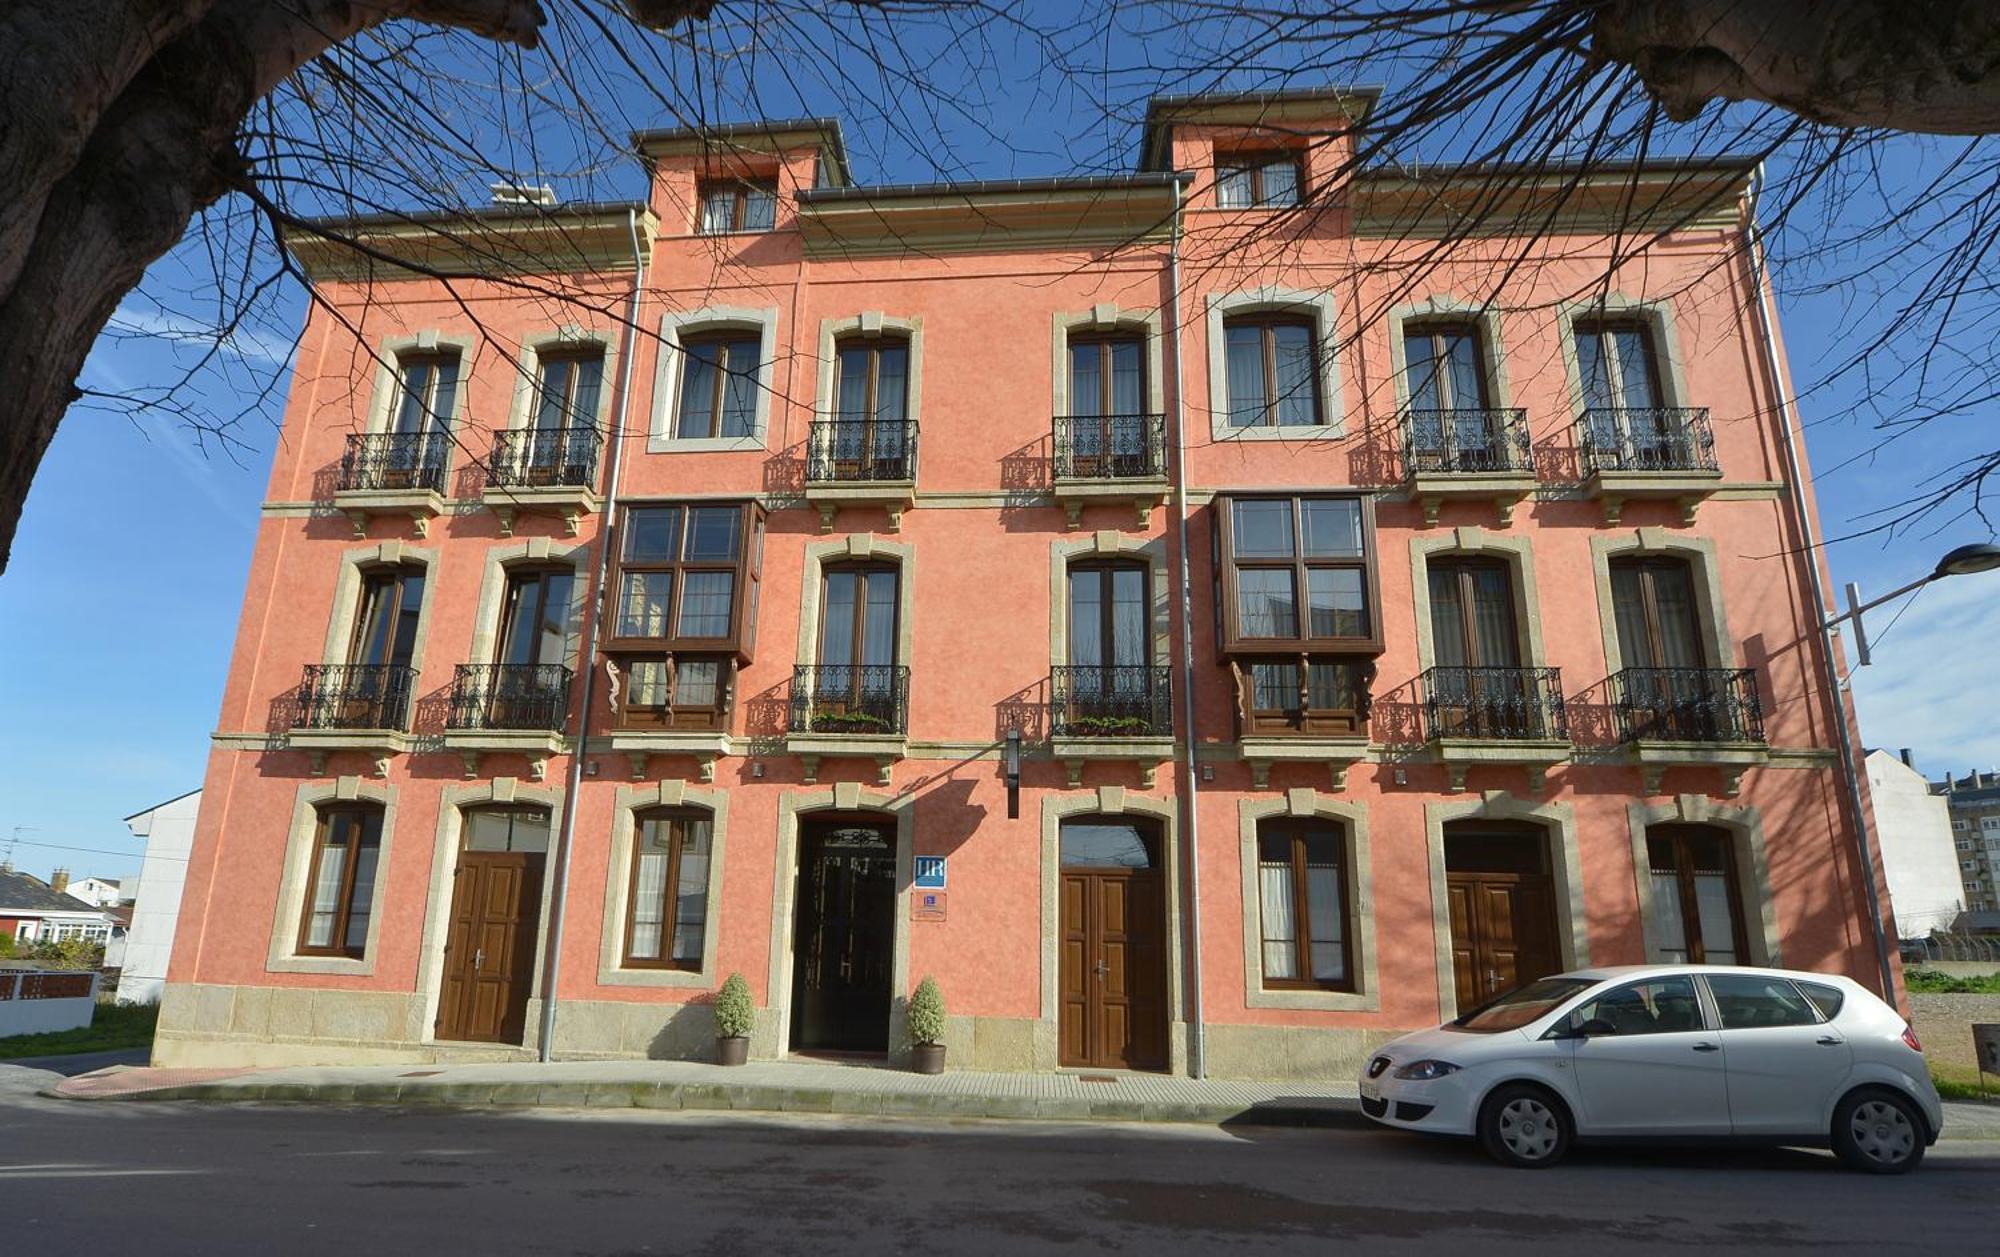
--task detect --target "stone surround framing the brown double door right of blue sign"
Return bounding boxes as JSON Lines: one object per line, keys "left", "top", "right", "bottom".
{"left": 1034, "top": 787, "right": 1188, "bottom": 1077}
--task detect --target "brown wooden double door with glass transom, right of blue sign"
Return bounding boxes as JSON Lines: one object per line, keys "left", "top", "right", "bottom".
{"left": 1056, "top": 821, "right": 1168, "bottom": 1069}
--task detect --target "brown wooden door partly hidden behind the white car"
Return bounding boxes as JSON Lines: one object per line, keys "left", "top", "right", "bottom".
{"left": 1444, "top": 827, "right": 1562, "bottom": 1013}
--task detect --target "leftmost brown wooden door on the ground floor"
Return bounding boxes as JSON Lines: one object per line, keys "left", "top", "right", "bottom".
{"left": 434, "top": 851, "right": 544, "bottom": 1043}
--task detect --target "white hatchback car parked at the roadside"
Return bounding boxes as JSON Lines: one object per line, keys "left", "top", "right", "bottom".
{"left": 1360, "top": 965, "right": 1944, "bottom": 1173}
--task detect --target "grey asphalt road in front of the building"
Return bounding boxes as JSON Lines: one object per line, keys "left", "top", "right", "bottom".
{"left": 0, "top": 1065, "right": 2000, "bottom": 1257}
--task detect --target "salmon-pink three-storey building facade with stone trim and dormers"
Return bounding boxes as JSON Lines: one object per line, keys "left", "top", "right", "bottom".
{"left": 156, "top": 92, "right": 1874, "bottom": 1077}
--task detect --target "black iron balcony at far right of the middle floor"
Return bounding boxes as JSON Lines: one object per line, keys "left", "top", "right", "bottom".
{"left": 1608, "top": 669, "right": 1770, "bottom": 797}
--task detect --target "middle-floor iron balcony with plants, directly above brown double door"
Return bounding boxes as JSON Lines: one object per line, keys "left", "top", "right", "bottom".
{"left": 1048, "top": 665, "right": 1174, "bottom": 789}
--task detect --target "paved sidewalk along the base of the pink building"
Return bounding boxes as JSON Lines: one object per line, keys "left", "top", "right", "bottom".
{"left": 44, "top": 1061, "right": 1364, "bottom": 1125}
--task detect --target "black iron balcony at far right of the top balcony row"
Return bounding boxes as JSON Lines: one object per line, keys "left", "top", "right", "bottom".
{"left": 1576, "top": 406, "right": 1722, "bottom": 524}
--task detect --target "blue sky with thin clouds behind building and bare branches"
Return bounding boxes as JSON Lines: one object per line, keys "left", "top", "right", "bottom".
{"left": 0, "top": 19, "right": 2000, "bottom": 877}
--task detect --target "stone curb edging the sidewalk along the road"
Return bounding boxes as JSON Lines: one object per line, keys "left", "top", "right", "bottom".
{"left": 40, "top": 1083, "right": 1370, "bottom": 1129}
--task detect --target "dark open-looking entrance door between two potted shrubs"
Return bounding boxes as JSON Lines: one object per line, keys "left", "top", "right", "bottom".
{"left": 792, "top": 823, "right": 896, "bottom": 1053}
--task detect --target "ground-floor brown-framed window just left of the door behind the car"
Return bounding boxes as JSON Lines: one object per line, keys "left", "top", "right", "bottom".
{"left": 1258, "top": 821, "right": 1352, "bottom": 991}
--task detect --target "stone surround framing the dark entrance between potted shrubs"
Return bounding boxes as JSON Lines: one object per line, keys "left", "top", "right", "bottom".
{"left": 764, "top": 781, "right": 916, "bottom": 1061}
